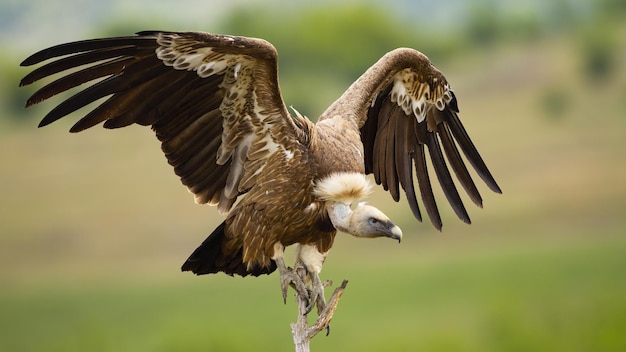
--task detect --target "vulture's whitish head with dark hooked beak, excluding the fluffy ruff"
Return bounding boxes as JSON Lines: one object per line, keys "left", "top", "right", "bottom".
{"left": 327, "top": 202, "right": 402, "bottom": 242}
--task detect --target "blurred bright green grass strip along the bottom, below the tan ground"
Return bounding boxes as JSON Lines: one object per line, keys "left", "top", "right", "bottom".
{"left": 0, "top": 241, "right": 626, "bottom": 351}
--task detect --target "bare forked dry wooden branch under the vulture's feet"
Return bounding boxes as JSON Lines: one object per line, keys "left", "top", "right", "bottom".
{"left": 291, "top": 267, "right": 348, "bottom": 352}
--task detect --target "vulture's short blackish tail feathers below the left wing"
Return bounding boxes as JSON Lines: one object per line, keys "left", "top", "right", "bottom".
{"left": 181, "top": 222, "right": 276, "bottom": 276}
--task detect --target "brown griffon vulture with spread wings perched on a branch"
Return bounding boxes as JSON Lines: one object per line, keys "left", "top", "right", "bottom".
{"left": 20, "top": 31, "right": 501, "bottom": 309}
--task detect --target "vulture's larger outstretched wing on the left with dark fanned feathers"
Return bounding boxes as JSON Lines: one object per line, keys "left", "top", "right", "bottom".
{"left": 20, "top": 32, "right": 304, "bottom": 212}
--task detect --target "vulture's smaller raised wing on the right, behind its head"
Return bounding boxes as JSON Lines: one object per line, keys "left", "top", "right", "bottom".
{"left": 323, "top": 49, "right": 501, "bottom": 229}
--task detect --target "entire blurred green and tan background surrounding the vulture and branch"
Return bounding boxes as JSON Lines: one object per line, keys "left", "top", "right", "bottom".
{"left": 0, "top": 0, "right": 626, "bottom": 351}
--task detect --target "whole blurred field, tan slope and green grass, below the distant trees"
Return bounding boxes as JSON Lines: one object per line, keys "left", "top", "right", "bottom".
{"left": 0, "top": 28, "right": 626, "bottom": 351}
